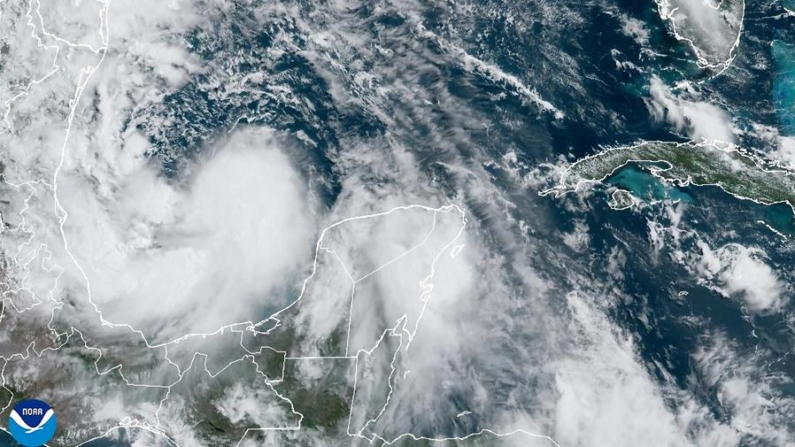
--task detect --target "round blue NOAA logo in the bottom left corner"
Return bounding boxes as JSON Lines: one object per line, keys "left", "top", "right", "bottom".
{"left": 8, "top": 399, "right": 55, "bottom": 447}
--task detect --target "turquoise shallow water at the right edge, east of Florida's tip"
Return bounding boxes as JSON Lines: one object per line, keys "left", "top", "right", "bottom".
{"left": 771, "top": 40, "right": 795, "bottom": 135}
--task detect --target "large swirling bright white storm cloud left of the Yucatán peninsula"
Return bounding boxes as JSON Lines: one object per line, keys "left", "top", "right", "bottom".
{"left": 63, "top": 131, "right": 313, "bottom": 344}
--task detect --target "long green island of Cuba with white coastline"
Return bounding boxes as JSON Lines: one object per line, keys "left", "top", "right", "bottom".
{"left": 553, "top": 141, "right": 795, "bottom": 209}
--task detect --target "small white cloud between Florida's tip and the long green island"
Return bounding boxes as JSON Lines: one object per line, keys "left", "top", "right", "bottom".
{"left": 645, "top": 76, "right": 735, "bottom": 143}
